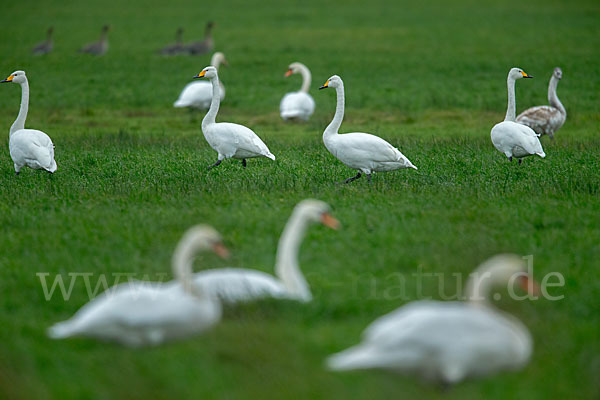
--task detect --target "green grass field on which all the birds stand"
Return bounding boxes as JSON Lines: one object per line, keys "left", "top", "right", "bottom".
{"left": 0, "top": 0, "right": 600, "bottom": 399}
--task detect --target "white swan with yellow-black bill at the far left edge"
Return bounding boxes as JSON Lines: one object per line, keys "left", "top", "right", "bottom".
{"left": 0, "top": 71, "right": 57, "bottom": 175}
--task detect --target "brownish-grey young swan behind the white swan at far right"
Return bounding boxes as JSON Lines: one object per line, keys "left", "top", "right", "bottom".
{"left": 517, "top": 67, "right": 567, "bottom": 139}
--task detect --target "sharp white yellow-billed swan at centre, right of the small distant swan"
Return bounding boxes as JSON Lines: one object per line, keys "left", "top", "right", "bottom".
{"left": 319, "top": 75, "right": 417, "bottom": 183}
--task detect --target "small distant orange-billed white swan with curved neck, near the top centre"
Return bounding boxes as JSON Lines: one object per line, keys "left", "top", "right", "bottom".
{"left": 279, "top": 62, "right": 315, "bottom": 121}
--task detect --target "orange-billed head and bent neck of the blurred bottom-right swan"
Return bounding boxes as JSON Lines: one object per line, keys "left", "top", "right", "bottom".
{"left": 467, "top": 254, "right": 539, "bottom": 301}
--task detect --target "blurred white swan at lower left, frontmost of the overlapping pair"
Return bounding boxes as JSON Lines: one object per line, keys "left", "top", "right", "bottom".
{"left": 48, "top": 225, "right": 227, "bottom": 347}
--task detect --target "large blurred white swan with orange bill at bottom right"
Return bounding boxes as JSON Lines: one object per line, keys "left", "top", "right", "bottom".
{"left": 327, "top": 254, "right": 538, "bottom": 385}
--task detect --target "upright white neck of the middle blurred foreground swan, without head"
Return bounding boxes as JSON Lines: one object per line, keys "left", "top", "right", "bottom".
{"left": 275, "top": 211, "right": 312, "bottom": 300}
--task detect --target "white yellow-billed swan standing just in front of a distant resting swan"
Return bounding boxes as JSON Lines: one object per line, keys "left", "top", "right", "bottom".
{"left": 194, "top": 66, "right": 275, "bottom": 169}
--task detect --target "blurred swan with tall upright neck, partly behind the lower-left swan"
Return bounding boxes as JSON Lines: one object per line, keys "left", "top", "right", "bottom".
{"left": 194, "top": 199, "right": 339, "bottom": 303}
